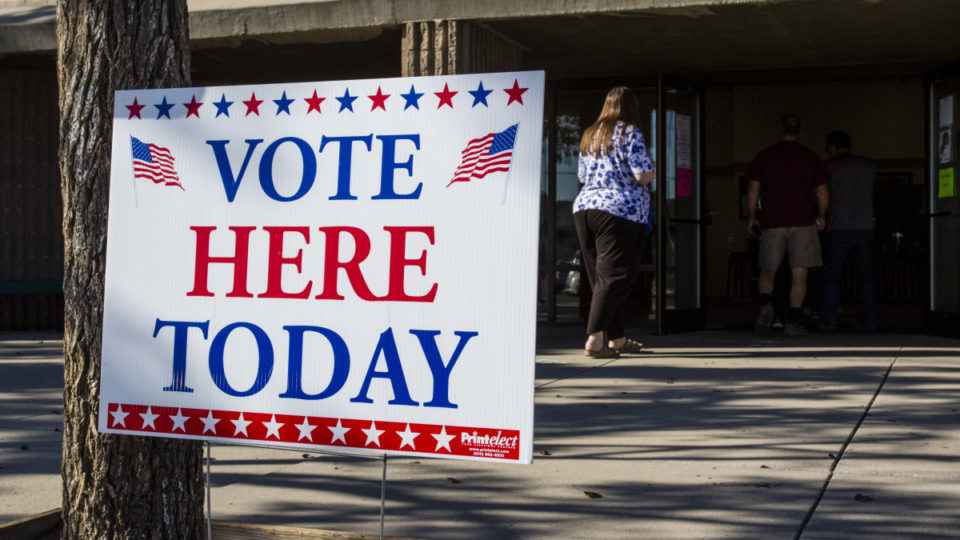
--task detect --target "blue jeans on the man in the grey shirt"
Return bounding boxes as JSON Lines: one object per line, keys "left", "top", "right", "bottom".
{"left": 820, "top": 230, "right": 877, "bottom": 327}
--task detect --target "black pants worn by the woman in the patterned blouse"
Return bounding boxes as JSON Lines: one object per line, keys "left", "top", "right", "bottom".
{"left": 573, "top": 210, "right": 647, "bottom": 340}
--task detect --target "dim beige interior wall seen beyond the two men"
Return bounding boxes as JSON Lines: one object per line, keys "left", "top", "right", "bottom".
{"left": 705, "top": 78, "right": 924, "bottom": 297}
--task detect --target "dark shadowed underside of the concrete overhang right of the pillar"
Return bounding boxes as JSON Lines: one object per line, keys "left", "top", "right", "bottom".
{"left": 485, "top": 0, "right": 960, "bottom": 81}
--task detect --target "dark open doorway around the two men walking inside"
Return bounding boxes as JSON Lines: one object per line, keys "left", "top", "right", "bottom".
{"left": 706, "top": 78, "right": 929, "bottom": 332}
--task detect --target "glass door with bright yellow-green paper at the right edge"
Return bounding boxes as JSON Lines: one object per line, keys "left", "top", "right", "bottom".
{"left": 927, "top": 70, "right": 960, "bottom": 337}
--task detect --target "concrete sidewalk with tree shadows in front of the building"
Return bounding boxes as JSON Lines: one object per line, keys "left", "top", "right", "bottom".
{"left": 0, "top": 326, "right": 960, "bottom": 539}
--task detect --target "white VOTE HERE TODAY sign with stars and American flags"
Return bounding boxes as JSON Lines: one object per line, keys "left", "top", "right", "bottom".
{"left": 99, "top": 72, "right": 544, "bottom": 463}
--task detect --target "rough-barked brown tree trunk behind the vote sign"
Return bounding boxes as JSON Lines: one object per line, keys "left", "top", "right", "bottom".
{"left": 57, "top": 0, "right": 204, "bottom": 539}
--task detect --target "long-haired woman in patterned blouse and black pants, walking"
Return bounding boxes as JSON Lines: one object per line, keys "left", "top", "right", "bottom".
{"left": 573, "top": 86, "right": 653, "bottom": 358}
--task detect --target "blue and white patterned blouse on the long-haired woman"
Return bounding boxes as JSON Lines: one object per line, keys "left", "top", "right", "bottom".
{"left": 573, "top": 122, "right": 653, "bottom": 229}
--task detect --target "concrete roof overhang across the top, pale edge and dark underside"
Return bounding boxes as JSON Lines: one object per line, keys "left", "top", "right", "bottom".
{"left": 0, "top": 0, "right": 960, "bottom": 83}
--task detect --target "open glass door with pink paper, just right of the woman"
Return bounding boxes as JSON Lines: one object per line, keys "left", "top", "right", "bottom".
{"left": 651, "top": 75, "right": 706, "bottom": 334}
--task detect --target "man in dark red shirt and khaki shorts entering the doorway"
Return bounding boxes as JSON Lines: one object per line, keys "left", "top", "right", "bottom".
{"left": 747, "top": 114, "right": 830, "bottom": 336}
